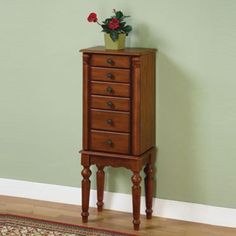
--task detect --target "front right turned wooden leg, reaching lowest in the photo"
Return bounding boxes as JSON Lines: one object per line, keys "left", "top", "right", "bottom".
{"left": 131, "top": 172, "right": 142, "bottom": 230}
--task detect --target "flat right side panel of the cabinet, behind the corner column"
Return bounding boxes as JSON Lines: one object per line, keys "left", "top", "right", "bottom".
{"left": 140, "top": 53, "right": 156, "bottom": 153}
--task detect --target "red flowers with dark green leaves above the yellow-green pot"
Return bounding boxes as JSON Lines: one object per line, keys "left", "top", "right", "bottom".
{"left": 87, "top": 9, "right": 132, "bottom": 42}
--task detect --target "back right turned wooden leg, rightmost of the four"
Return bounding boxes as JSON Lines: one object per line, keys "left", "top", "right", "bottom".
{"left": 144, "top": 160, "right": 153, "bottom": 219}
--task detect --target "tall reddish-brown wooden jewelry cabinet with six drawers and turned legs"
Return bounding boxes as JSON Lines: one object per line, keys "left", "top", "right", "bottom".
{"left": 81, "top": 47, "right": 156, "bottom": 230}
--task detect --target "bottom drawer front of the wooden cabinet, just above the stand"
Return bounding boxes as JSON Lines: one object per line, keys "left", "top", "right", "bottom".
{"left": 90, "top": 130, "right": 130, "bottom": 154}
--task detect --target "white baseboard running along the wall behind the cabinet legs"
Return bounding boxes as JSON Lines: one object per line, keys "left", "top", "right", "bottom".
{"left": 0, "top": 178, "right": 236, "bottom": 228}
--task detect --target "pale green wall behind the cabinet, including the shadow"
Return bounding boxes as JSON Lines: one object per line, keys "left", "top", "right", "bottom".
{"left": 0, "top": 0, "right": 236, "bottom": 208}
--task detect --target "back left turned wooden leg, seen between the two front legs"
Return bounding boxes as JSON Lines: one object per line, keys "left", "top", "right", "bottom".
{"left": 97, "top": 165, "right": 105, "bottom": 211}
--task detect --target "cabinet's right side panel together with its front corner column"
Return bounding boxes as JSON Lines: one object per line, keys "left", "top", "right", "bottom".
{"left": 132, "top": 53, "right": 156, "bottom": 155}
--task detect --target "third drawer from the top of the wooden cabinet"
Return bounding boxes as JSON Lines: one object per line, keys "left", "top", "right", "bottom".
{"left": 90, "top": 81, "right": 130, "bottom": 97}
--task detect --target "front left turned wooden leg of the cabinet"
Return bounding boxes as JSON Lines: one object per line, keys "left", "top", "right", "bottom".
{"left": 81, "top": 166, "right": 91, "bottom": 223}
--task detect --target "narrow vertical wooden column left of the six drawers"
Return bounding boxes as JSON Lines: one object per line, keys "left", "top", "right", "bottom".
{"left": 83, "top": 53, "right": 90, "bottom": 150}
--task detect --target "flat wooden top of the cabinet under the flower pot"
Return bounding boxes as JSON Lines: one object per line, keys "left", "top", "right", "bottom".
{"left": 80, "top": 46, "right": 157, "bottom": 56}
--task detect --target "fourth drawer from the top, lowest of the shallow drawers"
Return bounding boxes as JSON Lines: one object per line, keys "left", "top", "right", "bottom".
{"left": 90, "top": 95, "right": 130, "bottom": 111}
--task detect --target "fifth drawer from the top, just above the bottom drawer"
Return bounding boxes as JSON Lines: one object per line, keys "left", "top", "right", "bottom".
{"left": 90, "top": 110, "right": 130, "bottom": 132}
